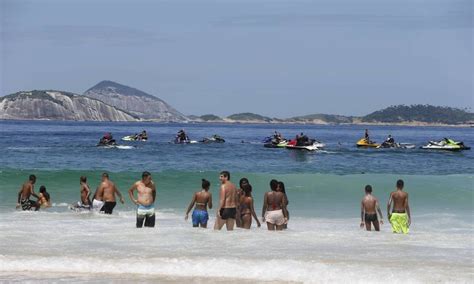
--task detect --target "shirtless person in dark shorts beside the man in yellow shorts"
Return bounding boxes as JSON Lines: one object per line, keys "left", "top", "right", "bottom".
{"left": 360, "top": 185, "right": 383, "bottom": 231}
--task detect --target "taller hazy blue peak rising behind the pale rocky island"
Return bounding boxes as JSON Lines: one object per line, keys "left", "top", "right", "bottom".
{"left": 84, "top": 81, "right": 188, "bottom": 122}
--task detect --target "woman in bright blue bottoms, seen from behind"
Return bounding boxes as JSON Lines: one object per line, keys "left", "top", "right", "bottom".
{"left": 184, "top": 179, "right": 212, "bottom": 228}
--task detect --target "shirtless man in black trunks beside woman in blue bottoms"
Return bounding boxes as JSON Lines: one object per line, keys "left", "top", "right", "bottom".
{"left": 214, "top": 171, "right": 239, "bottom": 231}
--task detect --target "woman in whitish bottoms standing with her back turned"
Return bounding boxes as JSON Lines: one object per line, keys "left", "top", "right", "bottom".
{"left": 262, "top": 179, "right": 288, "bottom": 231}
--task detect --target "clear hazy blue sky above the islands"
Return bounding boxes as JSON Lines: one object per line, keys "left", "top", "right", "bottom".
{"left": 0, "top": 0, "right": 474, "bottom": 118}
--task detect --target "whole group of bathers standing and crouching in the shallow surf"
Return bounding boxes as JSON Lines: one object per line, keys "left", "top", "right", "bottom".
{"left": 17, "top": 171, "right": 411, "bottom": 234}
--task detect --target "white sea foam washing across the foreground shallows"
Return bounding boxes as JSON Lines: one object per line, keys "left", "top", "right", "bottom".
{"left": 0, "top": 209, "right": 473, "bottom": 283}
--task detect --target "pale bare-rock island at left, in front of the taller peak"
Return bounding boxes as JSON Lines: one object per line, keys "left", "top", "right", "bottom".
{"left": 0, "top": 90, "right": 138, "bottom": 121}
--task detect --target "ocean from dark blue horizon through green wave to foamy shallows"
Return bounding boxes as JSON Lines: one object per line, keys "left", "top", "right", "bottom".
{"left": 0, "top": 121, "right": 474, "bottom": 283}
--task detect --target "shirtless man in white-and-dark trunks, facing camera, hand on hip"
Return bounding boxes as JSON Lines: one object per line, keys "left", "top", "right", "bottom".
{"left": 128, "top": 172, "right": 156, "bottom": 228}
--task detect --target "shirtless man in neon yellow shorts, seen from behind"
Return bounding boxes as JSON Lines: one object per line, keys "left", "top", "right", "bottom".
{"left": 387, "top": 179, "right": 411, "bottom": 234}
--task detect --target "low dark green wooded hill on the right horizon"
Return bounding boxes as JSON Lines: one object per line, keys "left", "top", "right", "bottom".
{"left": 361, "top": 105, "right": 474, "bottom": 124}
